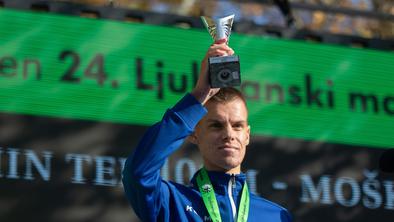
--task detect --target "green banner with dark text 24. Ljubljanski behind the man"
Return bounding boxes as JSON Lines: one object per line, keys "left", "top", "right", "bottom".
{"left": 0, "top": 9, "right": 394, "bottom": 147}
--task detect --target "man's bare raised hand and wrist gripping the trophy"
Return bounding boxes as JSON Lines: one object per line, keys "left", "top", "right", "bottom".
{"left": 191, "top": 39, "right": 234, "bottom": 104}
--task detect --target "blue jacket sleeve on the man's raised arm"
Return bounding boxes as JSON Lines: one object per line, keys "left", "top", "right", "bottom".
{"left": 122, "top": 94, "right": 207, "bottom": 221}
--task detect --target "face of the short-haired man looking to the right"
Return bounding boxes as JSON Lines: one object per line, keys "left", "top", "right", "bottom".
{"left": 191, "top": 99, "right": 250, "bottom": 173}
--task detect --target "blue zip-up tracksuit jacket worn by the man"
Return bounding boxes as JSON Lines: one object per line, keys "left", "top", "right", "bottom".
{"left": 123, "top": 94, "right": 291, "bottom": 222}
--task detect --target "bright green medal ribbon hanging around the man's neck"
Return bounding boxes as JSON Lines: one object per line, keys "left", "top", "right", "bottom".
{"left": 197, "top": 168, "right": 250, "bottom": 222}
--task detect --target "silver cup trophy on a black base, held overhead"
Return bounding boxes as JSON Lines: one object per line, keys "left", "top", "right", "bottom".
{"left": 201, "top": 15, "right": 241, "bottom": 88}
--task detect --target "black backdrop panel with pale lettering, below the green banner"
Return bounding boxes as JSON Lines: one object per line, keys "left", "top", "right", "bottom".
{"left": 0, "top": 113, "right": 394, "bottom": 222}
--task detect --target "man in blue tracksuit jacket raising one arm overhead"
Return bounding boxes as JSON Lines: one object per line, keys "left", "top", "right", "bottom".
{"left": 123, "top": 39, "right": 291, "bottom": 222}
